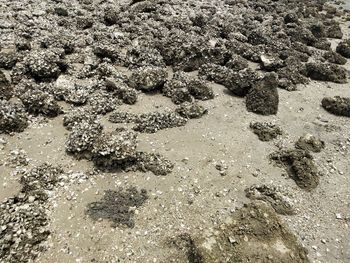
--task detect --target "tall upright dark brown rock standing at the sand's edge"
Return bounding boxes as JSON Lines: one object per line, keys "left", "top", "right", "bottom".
{"left": 246, "top": 73, "right": 279, "bottom": 115}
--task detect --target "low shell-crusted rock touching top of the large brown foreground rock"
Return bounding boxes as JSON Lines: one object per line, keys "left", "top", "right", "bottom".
{"left": 245, "top": 185, "right": 295, "bottom": 215}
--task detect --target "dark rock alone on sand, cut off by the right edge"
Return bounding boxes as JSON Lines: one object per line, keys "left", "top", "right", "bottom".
{"left": 322, "top": 96, "right": 350, "bottom": 117}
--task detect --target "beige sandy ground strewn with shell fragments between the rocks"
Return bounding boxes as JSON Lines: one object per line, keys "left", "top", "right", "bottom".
{"left": 0, "top": 3, "right": 350, "bottom": 263}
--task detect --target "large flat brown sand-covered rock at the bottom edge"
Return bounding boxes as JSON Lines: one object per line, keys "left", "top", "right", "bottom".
{"left": 183, "top": 201, "right": 310, "bottom": 263}
